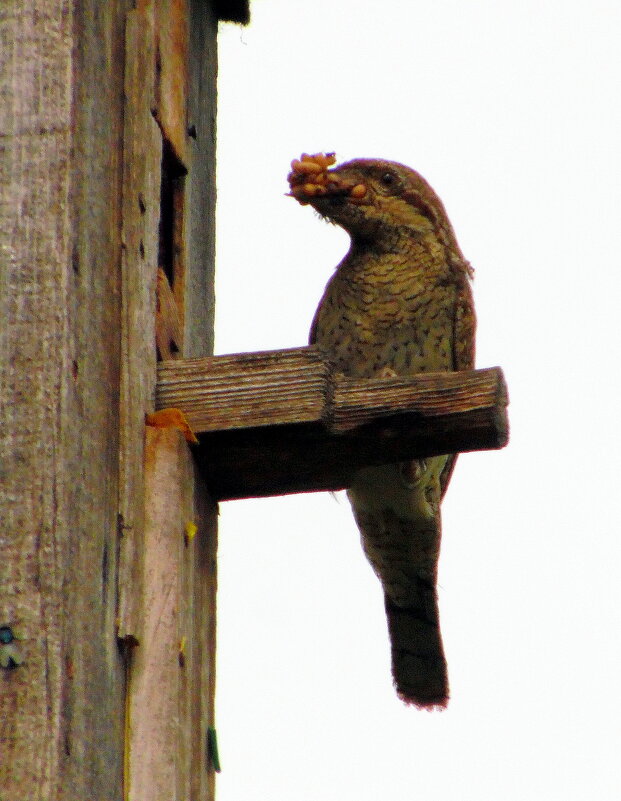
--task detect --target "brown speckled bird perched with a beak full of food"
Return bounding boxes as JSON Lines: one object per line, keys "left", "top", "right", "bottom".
{"left": 288, "top": 153, "right": 476, "bottom": 710}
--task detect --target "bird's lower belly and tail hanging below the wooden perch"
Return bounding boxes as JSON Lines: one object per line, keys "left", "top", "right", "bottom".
{"left": 348, "top": 456, "right": 449, "bottom": 709}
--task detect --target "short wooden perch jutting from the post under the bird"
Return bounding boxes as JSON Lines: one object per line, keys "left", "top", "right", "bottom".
{"left": 156, "top": 347, "right": 508, "bottom": 500}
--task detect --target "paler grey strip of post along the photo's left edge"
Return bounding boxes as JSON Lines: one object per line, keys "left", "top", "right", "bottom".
{"left": 0, "top": 2, "right": 72, "bottom": 798}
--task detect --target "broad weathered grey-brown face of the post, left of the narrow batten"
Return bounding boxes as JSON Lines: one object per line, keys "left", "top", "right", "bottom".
{"left": 0, "top": 0, "right": 130, "bottom": 801}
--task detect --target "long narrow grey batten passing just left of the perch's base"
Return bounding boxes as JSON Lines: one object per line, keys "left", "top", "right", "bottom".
{"left": 118, "top": 10, "right": 162, "bottom": 640}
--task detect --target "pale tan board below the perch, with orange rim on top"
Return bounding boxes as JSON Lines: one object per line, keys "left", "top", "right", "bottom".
{"left": 127, "top": 428, "right": 217, "bottom": 801}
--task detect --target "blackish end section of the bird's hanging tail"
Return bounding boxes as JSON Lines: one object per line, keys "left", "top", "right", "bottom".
{"left": 384, "top": 581, "right": 449, "bottom": 709}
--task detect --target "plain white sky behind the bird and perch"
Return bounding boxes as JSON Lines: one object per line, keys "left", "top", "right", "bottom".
{"left": 216, "top": 0, "right": 621, "bottom": 801}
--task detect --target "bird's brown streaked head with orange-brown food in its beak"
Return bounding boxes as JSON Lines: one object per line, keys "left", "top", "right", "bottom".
{"left": 289, "top": 153, "right": 458, "bottom": 251}
